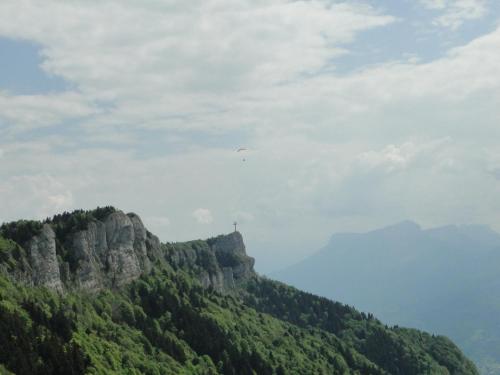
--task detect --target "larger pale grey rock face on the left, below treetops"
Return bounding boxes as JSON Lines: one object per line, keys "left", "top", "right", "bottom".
{"left": 11, "top": 211, "right": 161, "bottom": 292}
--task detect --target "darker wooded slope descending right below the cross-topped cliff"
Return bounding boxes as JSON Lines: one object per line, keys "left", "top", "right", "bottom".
{"left": 242, "top": 278, "right": 476, "bottom": 375}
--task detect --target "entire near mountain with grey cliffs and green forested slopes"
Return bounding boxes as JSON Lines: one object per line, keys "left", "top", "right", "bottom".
{"left": 0, "top": 207, "right": 477, "bottom": 375}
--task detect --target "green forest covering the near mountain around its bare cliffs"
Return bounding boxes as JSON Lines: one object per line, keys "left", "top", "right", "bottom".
{"left": 0, "top": 208, "right": 477, "bottom": 375}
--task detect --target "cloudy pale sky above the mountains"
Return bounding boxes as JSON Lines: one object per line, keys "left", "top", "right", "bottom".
{"left": 0, "top": 0, "right": 500, "bottom": 273}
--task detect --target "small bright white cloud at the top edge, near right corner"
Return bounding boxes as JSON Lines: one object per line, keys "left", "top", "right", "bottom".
{"left": 420, "top": 0, "right": 488, "bottom": 30}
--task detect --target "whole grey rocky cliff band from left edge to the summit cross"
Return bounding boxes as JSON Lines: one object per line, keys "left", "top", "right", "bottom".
{"left": 0, "top": 209, "right": 255, "bottom": 292}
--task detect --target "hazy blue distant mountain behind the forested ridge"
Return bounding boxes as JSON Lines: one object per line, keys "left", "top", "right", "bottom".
{"left": 273, "top": 221, "right": 500, "bottom": 375}
